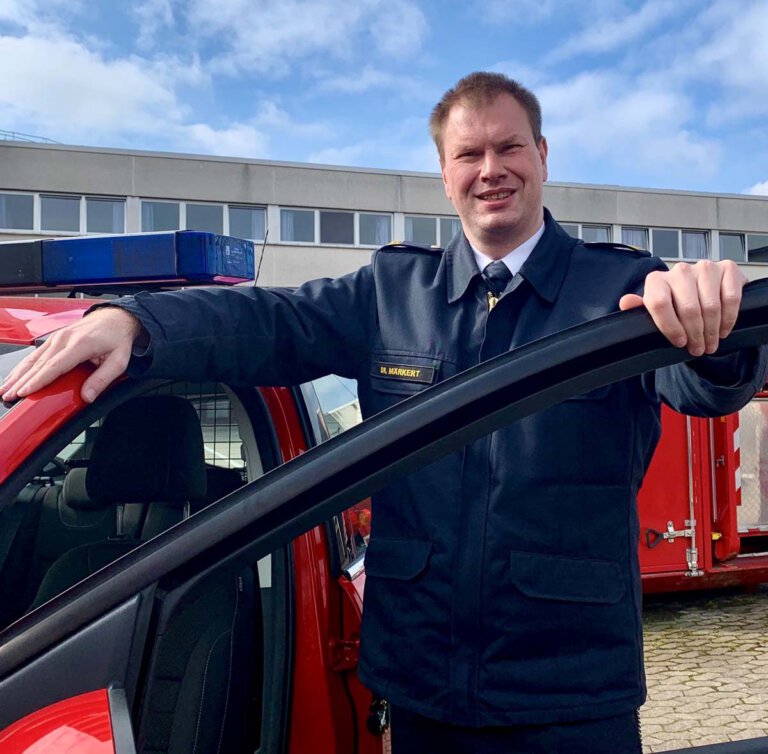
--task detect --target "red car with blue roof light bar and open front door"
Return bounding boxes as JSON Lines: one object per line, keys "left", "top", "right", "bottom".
{"left": 0, "top": 233, "right": 385, "bottom": 754}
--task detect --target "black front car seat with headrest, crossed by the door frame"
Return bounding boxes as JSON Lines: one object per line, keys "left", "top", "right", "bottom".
{"left": 28, "top": 396, "right": 261, "bottom": 754}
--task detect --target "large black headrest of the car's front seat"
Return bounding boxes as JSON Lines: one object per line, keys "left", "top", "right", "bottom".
{"left": 86, "top": 395, "right": 206, "bottom": 504}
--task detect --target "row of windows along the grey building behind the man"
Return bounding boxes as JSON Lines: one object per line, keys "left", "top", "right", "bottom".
{"left": 0, "top": 193, "right": 768, "bottom": 262}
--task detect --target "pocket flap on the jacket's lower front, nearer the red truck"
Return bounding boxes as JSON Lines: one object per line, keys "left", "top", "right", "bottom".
{"left": 510, "top": 552, "right": 626, "bottom": 604}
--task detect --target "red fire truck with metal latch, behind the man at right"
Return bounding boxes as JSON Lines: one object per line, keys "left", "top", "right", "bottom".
{"left": 638, "top": 393, "right": 768, "bottom": 593}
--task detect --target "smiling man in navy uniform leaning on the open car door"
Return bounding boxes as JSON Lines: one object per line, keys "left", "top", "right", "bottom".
{"left": 3, "top": 74, "right": 766, "bottom": 754}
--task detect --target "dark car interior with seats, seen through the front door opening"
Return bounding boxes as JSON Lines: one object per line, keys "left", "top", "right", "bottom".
{"left": 0, "top": 383, "right": 289, "bottom": 754}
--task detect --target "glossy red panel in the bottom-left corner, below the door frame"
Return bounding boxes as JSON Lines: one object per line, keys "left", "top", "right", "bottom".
{"left": 0, "top": 689, "right": 115, "bottom": 754}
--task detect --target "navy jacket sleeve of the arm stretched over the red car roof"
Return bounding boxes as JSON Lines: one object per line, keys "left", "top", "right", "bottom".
{"left": 100, "top": 267, "right": 376, "bottom": 385}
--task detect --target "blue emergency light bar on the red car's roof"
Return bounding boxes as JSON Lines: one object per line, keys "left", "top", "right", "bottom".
{"left": 0, "top": 230, "right": 254, "bottom": 288}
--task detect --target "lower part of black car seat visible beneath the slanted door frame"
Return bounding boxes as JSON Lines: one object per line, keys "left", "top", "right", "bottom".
{"left": 137, "top": 568, "right": 263, "bottom": 754}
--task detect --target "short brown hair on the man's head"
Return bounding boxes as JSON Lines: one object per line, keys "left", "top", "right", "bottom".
{"left": 429, "top": 71, "right": 541, "bottom": 162}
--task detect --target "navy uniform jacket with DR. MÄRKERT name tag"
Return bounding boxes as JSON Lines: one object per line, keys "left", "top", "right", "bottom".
{"left": 115, "top": 212, "right": 766, "bottom": 725}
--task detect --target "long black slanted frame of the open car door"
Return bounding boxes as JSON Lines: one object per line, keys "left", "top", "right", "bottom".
{"left": 0, "top": 281, "right": 768, "bottom": 754}
